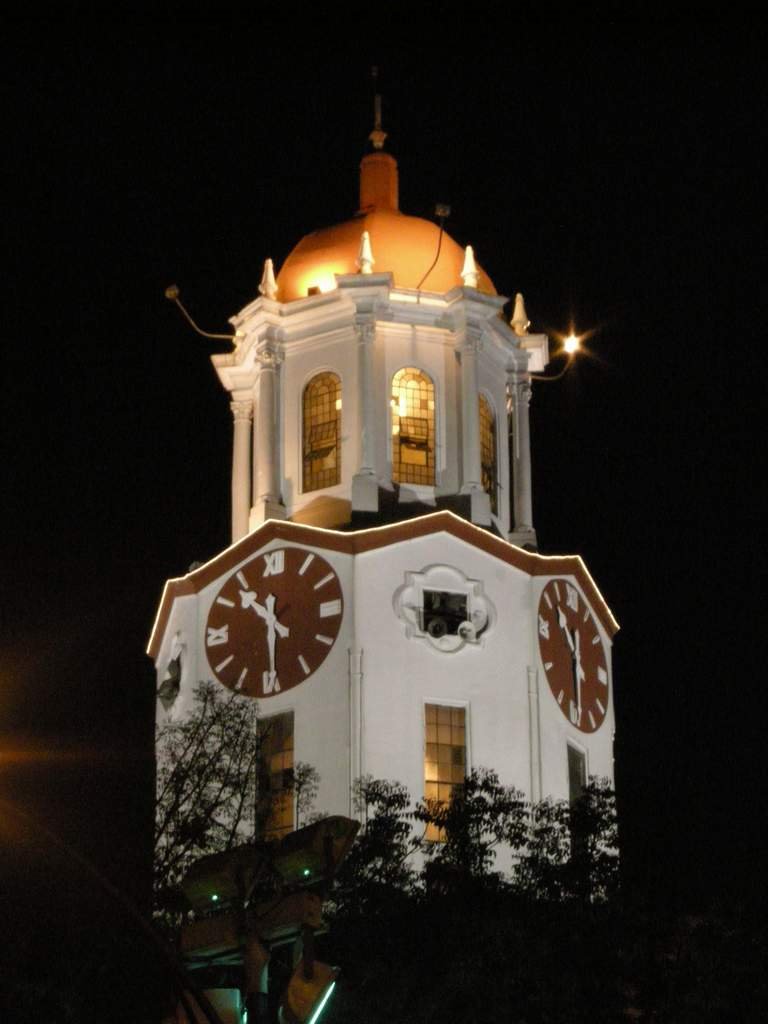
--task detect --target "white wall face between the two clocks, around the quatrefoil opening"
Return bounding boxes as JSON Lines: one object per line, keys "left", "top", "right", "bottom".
{"left": 355, "top": 535, "right": 529, "bottom": 799}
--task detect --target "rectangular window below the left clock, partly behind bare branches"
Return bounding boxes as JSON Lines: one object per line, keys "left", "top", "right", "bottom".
{"left": 258, "top": 712, "right": 294, "bottom": 839}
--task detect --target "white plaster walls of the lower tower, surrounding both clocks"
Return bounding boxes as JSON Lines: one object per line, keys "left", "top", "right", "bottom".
{"left": 158, "top": 534, "right": 614, "bottom": 847}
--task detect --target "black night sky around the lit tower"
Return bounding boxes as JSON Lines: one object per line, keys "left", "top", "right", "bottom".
{"left": 0, "top": 17, "right": 768, "bottom": 929}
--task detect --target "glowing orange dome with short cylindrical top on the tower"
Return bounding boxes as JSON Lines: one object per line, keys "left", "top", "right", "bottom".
{"left": 278, "top": 153, "right": 497, "bottom": 302}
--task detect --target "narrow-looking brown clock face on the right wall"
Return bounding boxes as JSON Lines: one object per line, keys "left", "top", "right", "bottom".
{"left": 539, "top": 580, "right": 608, "bottom": 732}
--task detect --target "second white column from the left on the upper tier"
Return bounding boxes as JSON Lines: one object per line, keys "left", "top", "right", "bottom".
{"left": 250, "top": 345, "right": 286, "bottom": 529}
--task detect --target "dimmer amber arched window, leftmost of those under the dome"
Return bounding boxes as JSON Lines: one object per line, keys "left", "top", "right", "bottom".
{"left": 302, "top": 373, "right": 341, "bottom": 490}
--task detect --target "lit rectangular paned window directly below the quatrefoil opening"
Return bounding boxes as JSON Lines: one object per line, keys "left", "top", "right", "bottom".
{"left": 424, "top": 705, "right": 467, "bottom": 842}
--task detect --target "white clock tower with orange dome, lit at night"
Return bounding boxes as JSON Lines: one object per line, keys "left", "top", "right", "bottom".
{"left": 148, "top": 116, "right": 617, "bottom": 860}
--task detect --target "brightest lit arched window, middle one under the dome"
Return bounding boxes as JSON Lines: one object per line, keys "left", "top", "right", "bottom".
{"left": 392, "top": 367, "right": 434, "bottom": 484}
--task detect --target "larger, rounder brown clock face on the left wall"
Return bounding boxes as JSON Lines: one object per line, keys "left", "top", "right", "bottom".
{"left": 205, "top": 548, "right": 344, "bottom": 697}
